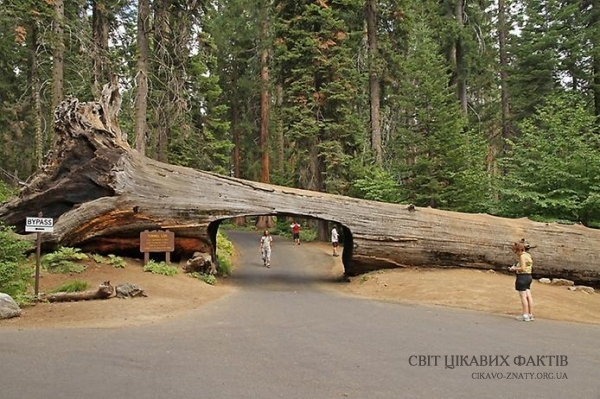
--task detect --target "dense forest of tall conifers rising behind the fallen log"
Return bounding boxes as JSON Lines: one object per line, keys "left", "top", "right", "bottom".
{"left": 0, "top": 0, "right": 600, "bottom": 227}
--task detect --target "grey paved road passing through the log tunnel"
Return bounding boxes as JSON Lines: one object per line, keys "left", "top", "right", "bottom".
{"left": 0, "top": 233, "right": 600, "bottom": 399}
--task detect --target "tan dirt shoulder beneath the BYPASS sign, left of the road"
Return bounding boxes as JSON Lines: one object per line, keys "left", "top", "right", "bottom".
{"left": 0, "top": 260, "right": 235, "bottom": 328}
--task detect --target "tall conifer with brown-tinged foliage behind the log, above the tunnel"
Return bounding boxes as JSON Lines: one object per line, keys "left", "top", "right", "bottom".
{"left": 274, "top": 0, "right": 367, "bottom": 194}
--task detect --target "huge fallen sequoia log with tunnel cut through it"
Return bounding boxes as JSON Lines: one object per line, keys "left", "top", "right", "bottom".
{"left": 0, "top": 95, "right": 600, "bottom": 285}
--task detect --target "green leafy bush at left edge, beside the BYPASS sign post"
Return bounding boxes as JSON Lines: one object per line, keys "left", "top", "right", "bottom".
{"left": 0, "top": 225, "right": 31, "bottom": 300}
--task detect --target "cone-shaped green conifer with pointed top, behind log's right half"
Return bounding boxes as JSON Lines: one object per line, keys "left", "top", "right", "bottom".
{"left": 384, "top": 13, "right": 489, "bottom": 211}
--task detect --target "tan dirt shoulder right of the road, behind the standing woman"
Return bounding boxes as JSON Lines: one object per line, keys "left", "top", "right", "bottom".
{"left": 330, "top": 266, "right": 600, "bottom": 324}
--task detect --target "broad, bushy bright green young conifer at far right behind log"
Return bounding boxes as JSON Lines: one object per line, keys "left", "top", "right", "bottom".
{"left": 500, "top": 93, "right": 600, "bottom": 224}
